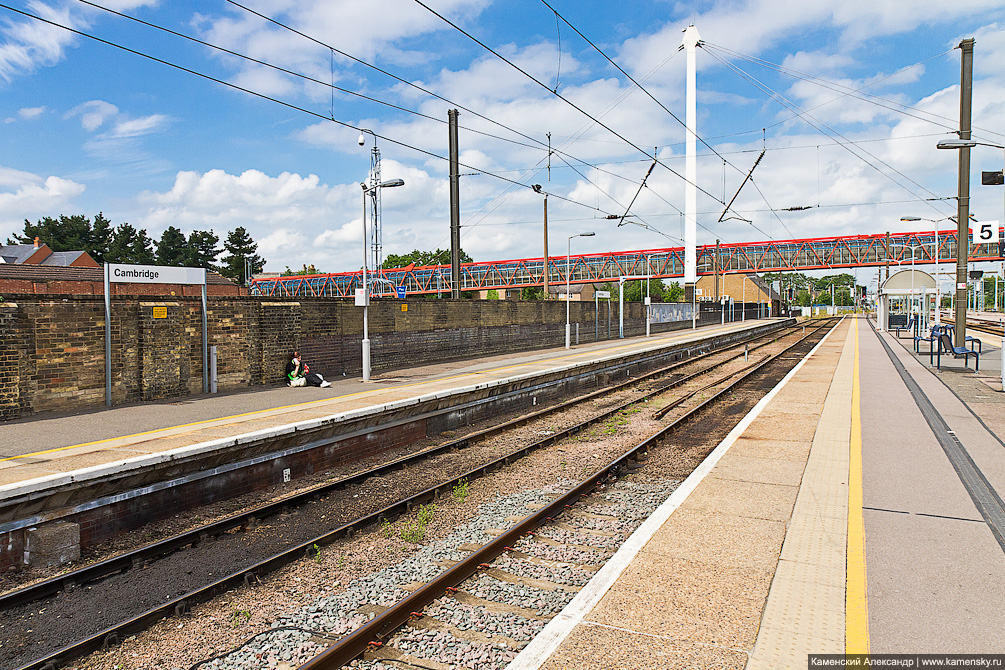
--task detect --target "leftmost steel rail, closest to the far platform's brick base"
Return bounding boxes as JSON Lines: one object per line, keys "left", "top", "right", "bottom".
{"left": 0, "top": 321, "right": 778, "bottom": 612}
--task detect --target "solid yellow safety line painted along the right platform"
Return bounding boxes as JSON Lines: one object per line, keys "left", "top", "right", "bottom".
{"left": 844, "top": 318, "right": 869, "bottom": 655}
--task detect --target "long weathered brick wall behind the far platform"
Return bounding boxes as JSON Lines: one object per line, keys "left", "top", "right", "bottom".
{"left": 0, "top": 295, "right": 719, "bottom": 419}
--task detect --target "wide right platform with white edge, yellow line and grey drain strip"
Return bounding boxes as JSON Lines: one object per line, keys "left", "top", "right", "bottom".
{"left": 509, "top": 316, "right": 1005, "bottom": 670}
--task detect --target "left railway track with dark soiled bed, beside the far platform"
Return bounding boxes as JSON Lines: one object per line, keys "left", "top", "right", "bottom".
{"left": 0, "top": 319, "right": 836, "bottom": 669}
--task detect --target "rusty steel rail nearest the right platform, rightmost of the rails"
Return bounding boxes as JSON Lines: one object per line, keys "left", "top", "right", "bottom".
{"left": 299, "top": 322, "right": 834, "bottom": 670}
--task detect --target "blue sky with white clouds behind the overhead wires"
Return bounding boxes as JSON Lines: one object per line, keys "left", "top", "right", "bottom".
{"left": 0, "top": 0, "right": 1005, "bottom": 271}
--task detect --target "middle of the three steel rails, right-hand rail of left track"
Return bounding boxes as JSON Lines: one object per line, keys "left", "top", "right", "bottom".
{"left": 18, "top": 319, "right": 826, "bottom": 670}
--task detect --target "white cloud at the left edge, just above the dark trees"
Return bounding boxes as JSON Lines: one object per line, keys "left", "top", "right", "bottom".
{"left": 0, "top": 167, "right": 86, "bottom": 239}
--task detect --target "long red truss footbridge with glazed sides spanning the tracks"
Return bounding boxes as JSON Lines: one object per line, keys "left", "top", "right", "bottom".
{"left": 251, "top": 230, "right": 1005, "bottom": 297}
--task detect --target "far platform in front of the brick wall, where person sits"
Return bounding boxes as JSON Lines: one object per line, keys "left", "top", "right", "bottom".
{"left": 0, "top": 319, "right": 778, "bottom": 500}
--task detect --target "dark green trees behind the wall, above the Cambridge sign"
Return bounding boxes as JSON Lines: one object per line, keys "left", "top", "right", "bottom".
{"left": 7, "top": 212, "right": 265, "bottom": 283}
